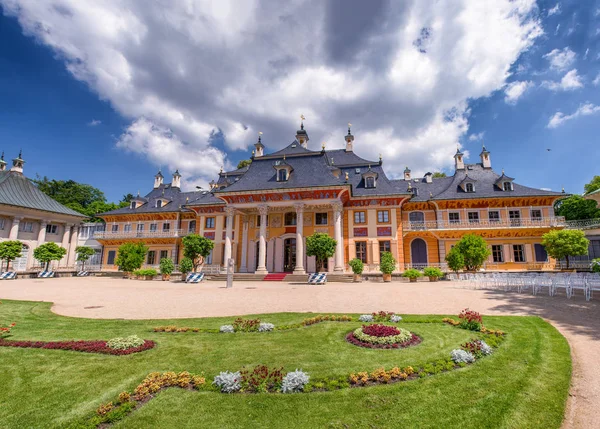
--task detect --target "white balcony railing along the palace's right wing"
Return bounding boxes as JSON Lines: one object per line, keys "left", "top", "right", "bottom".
{"left": 402, "top": 216, "right": 566, "bottom": 232}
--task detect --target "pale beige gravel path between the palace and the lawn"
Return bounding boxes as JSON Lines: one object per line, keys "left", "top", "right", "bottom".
{"left": 0, "top": 277, "right": 600, "bottom": 429}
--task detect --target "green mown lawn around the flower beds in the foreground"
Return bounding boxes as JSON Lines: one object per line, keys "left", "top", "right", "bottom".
{"left": 0, "top": 301, "right": 571, "bottom": 428}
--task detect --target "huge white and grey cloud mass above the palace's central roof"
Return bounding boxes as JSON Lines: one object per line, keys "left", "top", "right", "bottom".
{"left": 0, "top": 0, "right": 543, "bottom": 183}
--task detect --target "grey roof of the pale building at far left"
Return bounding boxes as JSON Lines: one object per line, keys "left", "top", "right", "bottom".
{"left": 0, "top": 171, "right": 86, "bottom": 219}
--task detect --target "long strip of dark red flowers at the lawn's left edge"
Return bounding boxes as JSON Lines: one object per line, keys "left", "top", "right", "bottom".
{"left": 0, "top": 339, "right": 155, "bottom": 355}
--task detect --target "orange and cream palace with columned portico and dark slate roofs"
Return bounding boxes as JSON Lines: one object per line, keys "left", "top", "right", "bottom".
{"left": 95, "top": 124, "right": 565, "bottom": 274}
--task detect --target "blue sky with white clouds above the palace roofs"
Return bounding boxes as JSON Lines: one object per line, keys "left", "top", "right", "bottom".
{"left": 0, "top": 0, "right": 600, "bottom": 200}
